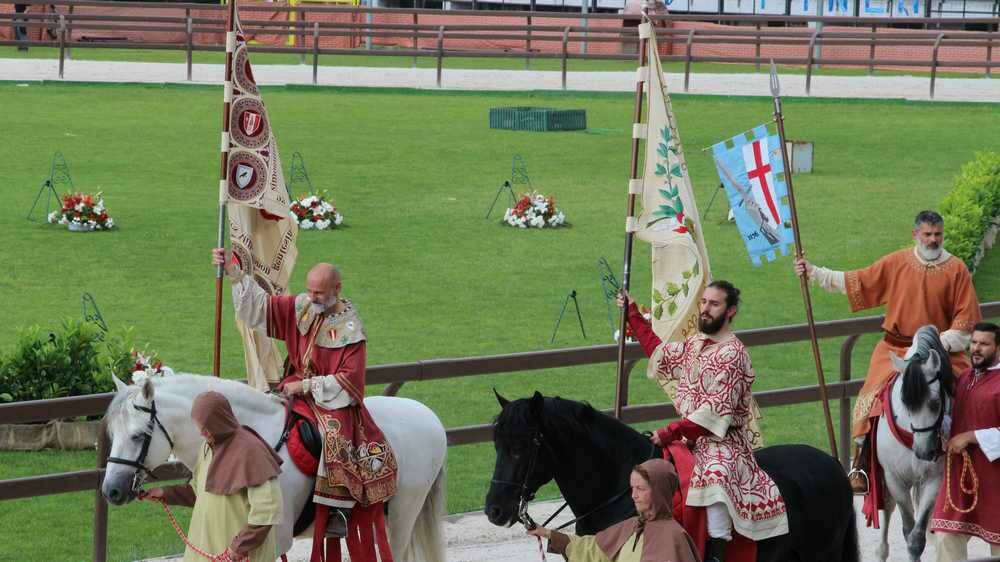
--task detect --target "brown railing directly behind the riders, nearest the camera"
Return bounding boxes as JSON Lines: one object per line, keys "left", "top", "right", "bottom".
{"left": 0, "top": 301, "right": 1000, "bottom": 562}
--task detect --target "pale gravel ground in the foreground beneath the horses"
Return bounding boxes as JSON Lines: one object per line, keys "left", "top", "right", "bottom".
{"left": 141, "top": 498, "right": 989, "bottom": 562}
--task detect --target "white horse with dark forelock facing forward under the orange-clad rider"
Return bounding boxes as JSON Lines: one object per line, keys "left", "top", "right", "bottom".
{"left": 872, "top": 326, "right": 955, "bottom": 562}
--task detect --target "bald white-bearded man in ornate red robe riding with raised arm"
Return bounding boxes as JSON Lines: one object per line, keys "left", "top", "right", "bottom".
{"left": 212, "top": 248, "right": 396, "bottom": 537}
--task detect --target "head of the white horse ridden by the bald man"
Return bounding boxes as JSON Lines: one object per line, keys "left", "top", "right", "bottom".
{"left": 101, "top": 378, "right": 173, "bottom": 505}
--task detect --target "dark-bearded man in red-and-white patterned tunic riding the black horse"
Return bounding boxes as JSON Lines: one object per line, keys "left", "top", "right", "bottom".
{"left": 618, "top": 280, "right": 788, "bottom": 562}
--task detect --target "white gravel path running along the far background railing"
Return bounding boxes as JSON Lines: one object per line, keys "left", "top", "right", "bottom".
{"left": 0, "top": 59, "right": 1000, "bottom": 103}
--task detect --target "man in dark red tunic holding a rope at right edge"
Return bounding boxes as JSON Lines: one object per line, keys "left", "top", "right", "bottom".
{"left": 930, "top": 322, "right": 1000, "bottom": 562}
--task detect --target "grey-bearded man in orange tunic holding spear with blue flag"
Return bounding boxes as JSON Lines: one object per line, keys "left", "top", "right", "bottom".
{"left": 795, "top": 211, "right": 982, "bottom": 493}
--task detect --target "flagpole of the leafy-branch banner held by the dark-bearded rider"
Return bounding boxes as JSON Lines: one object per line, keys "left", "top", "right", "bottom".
{"left": 614, "top": 15, "right": 652, "bottom": 419}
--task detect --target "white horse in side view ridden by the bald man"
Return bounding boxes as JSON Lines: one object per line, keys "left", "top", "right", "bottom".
{"left": 101, "top": 374, "right": 447, "bottom": 562}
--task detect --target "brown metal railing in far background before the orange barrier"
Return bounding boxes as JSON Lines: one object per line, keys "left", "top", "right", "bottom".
{"left": 0, "top": 0, "right": 1000, "bottom": 97}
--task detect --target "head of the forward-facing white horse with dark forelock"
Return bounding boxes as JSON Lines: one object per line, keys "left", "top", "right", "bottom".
{"left": 891, "top": 325, "right": 955, "bottom": 461}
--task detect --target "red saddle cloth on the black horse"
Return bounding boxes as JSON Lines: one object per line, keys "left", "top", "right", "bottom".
{"left": 663, "top": 441, "right": 757, "bottom": 562}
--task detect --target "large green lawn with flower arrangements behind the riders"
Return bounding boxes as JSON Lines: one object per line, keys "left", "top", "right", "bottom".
{"left": 0, "top": 80, "right": 1000, "bottom": 562}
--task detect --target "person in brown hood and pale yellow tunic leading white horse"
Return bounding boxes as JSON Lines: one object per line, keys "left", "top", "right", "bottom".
{"left": 147, "top": 392, "right": 282, "bottom": 562}
